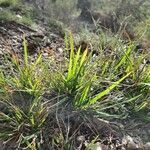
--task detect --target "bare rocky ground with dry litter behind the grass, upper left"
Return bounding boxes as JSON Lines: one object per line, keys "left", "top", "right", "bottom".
{"left": 0, "top": 21, "right": 64, "bottom": 63}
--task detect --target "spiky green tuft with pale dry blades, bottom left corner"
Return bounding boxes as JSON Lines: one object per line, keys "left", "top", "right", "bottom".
{"left": 0, "top": 96, "right": 48, "bottom": 149}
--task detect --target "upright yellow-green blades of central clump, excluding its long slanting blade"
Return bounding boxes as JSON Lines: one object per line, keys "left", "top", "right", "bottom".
{"left": 50, "top": 33, "right": 91, "bottom": 96}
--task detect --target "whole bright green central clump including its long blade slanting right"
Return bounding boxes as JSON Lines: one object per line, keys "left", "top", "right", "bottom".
{"left": 51, "top": 33, "right": 131, "bottom": 108}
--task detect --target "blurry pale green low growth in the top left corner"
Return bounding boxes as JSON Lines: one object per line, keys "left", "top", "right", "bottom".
{"left": 0, "top": 0, "right": 37, "bottom": 25}
